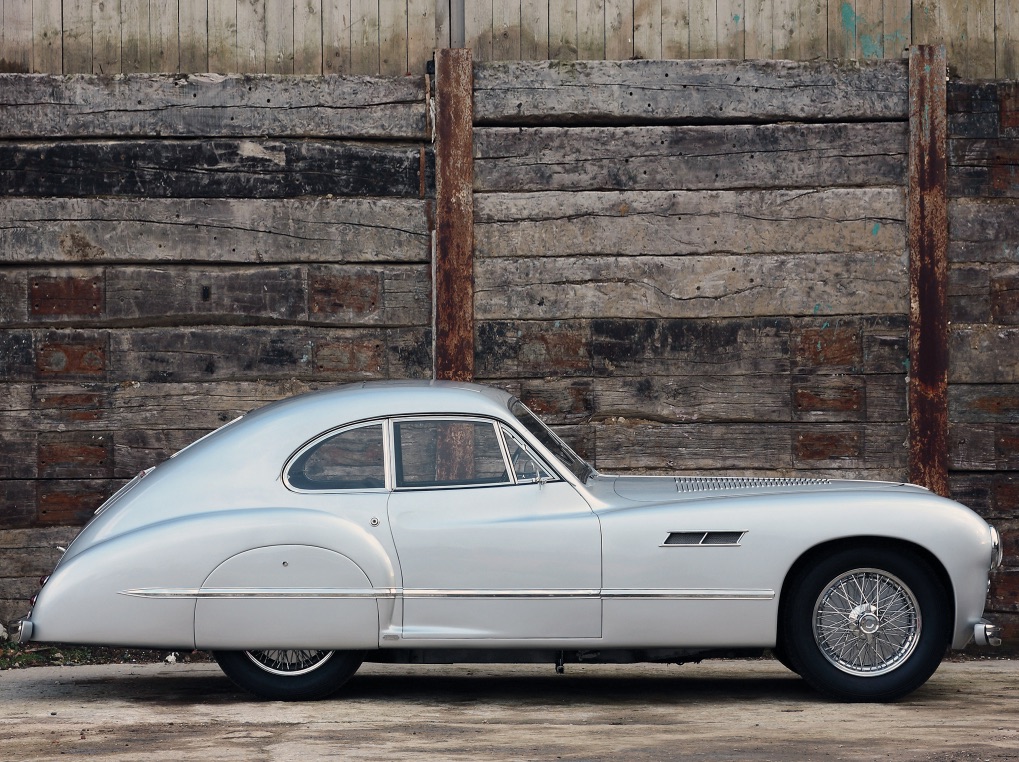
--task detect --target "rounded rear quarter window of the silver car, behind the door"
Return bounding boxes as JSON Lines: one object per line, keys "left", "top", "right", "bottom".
{"left": 286, "top": 424, "right": 385, "bottom": 490}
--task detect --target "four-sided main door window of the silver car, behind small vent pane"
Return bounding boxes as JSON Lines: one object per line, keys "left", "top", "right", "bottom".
{"left": 393, "top": 420, "right": 511, "bottom": 487}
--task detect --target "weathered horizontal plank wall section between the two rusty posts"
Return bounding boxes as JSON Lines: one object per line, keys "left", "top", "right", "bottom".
{"left": 474, "top": 56, "right": 908, "bottom": 479}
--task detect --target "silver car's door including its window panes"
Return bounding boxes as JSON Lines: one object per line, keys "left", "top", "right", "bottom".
{"left": 388, "top": 417, "right": 601, "bottom": 641}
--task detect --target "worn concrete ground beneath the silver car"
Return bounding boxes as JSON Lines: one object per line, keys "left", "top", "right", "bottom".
{"left": 0, "top": 660, "right": 1019, "bottom": 762}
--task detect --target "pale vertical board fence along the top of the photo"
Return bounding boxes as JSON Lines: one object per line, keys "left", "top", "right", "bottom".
{"left": 0, "top": 0, "right": 1019, "bottom": 78}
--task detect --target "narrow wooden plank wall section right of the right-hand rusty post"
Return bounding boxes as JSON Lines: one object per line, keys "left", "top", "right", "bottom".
{"left": 948, "top": 81, "right": 1019, "bottom": 629}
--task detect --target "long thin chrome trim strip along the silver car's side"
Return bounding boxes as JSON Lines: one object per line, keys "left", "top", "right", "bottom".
{"left": 119, "top": 588, "right": 774, "bottom": 601}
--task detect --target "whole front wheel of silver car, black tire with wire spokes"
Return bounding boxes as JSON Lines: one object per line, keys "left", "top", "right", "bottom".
{"left": 780, "top": 547, "right": 952, "bottom": 702}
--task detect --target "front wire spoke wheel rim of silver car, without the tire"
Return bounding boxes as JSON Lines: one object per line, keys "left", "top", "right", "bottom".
{"left": 814, "top": 568, "right": 922, "bottom": 676}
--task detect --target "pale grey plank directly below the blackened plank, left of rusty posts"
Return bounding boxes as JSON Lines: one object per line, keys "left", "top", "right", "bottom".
{"left": 0, "top": 198, "right": 431, "bottom": 264}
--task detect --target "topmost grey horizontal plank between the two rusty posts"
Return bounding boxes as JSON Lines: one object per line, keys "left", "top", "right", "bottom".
{"left": 474, "top": 60, "right": 908, "bottom": 125}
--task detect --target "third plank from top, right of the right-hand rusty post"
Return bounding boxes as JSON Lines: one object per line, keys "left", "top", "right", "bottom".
{"left": 949, "top": 199, "right": 1019, "bottom": 263}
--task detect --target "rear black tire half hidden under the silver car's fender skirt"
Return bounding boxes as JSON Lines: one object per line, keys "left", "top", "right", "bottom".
{"left": 212, "top": 649, "right": 362, "bottom": 701}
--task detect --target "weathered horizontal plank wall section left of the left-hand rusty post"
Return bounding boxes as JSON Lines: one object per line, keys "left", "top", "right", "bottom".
{"left": 0, "top": 69, "right": 435, "bottom": 620}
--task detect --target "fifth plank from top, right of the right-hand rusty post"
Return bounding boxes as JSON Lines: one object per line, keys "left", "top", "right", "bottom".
{"left": 949, "top": 325, "right": 1019, "bottom": 384}
